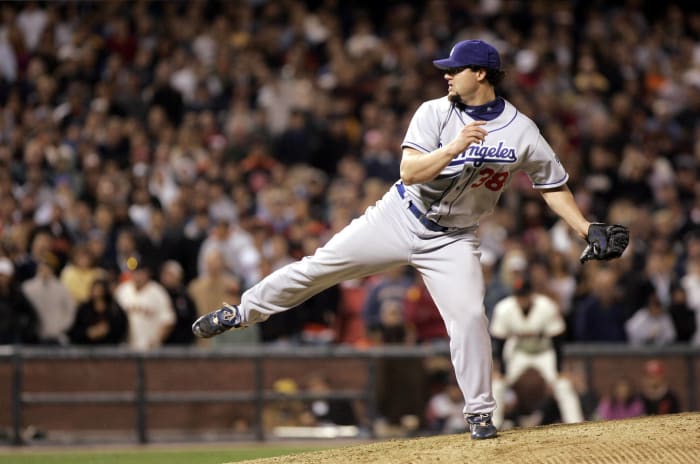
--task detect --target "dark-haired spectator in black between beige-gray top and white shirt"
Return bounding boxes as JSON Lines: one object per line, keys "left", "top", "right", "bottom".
{"left": 68, "top": 278, "right": 128, "bottom": 345}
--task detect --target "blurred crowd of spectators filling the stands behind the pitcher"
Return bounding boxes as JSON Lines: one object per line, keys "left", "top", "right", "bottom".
{"left": 0, "top": 0, "right": 700, "bottom": 356}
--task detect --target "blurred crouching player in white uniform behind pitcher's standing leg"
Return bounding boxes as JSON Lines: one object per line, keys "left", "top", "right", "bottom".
{"left": 491, "top": 277, "right": 583, "bottom": 427}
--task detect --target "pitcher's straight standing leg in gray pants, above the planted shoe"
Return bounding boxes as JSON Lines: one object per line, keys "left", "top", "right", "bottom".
{"left": 411, "top": 237, "right": 496, "bottom": 414}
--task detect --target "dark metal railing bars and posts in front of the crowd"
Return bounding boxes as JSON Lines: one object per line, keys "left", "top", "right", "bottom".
{"left": 0, "top": 344, "right": 700, "bottom": 445}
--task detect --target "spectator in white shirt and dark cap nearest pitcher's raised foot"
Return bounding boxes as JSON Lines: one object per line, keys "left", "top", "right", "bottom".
{"left": 114, "top": 258, "right": 175, "bottom": 351}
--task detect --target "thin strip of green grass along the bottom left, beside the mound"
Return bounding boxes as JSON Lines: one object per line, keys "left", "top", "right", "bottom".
{"left": 0, "top": 445, "right": 329, "bottom": 464}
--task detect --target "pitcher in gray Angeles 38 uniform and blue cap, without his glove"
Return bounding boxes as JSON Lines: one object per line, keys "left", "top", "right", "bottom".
{"left": 192, "top": 40, "right": 590, "bottom": 439}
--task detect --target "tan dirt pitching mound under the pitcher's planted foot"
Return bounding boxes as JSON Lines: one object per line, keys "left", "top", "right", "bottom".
{"left": 237, "top": 413, "right": 700, "bottom": 464}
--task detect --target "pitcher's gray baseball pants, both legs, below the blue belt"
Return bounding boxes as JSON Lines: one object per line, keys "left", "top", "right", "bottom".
{"left": 240, "top": 188, "right": 496, "bottom": 414}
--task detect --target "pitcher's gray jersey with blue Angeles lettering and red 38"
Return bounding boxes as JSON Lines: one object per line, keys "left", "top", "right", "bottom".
{"left": 402, "top": 97, "right": 569, "bottom": 227}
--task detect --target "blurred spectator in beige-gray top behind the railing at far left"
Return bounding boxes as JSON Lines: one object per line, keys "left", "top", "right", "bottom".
{"left": 22, "top": 252, "right": 76, "bottom": 345}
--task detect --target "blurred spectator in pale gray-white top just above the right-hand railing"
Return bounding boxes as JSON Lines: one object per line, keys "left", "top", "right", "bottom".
{"left": 625, "top": 293, "right": 676, "bottom": 346}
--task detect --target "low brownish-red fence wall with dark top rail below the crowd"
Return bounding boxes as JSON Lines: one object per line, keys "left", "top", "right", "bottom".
{"left": 0, "top": 345, "right": 700, "bottom": 445}
